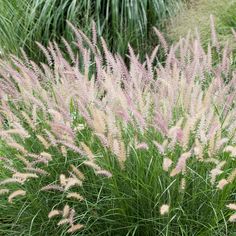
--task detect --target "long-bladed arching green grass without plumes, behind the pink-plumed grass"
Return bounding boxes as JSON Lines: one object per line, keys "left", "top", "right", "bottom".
{"left": 0, "top": 0, "right": 182, "bottom": 60}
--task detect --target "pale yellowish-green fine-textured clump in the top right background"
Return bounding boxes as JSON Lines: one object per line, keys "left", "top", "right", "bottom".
{"left": 169, "top": 0, "right": 236, "bottom": 50}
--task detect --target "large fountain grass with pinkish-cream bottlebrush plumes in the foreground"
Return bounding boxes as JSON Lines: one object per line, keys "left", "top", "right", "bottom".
{"left": 0, "top": 21, "right": 236, "bottom": 236}
